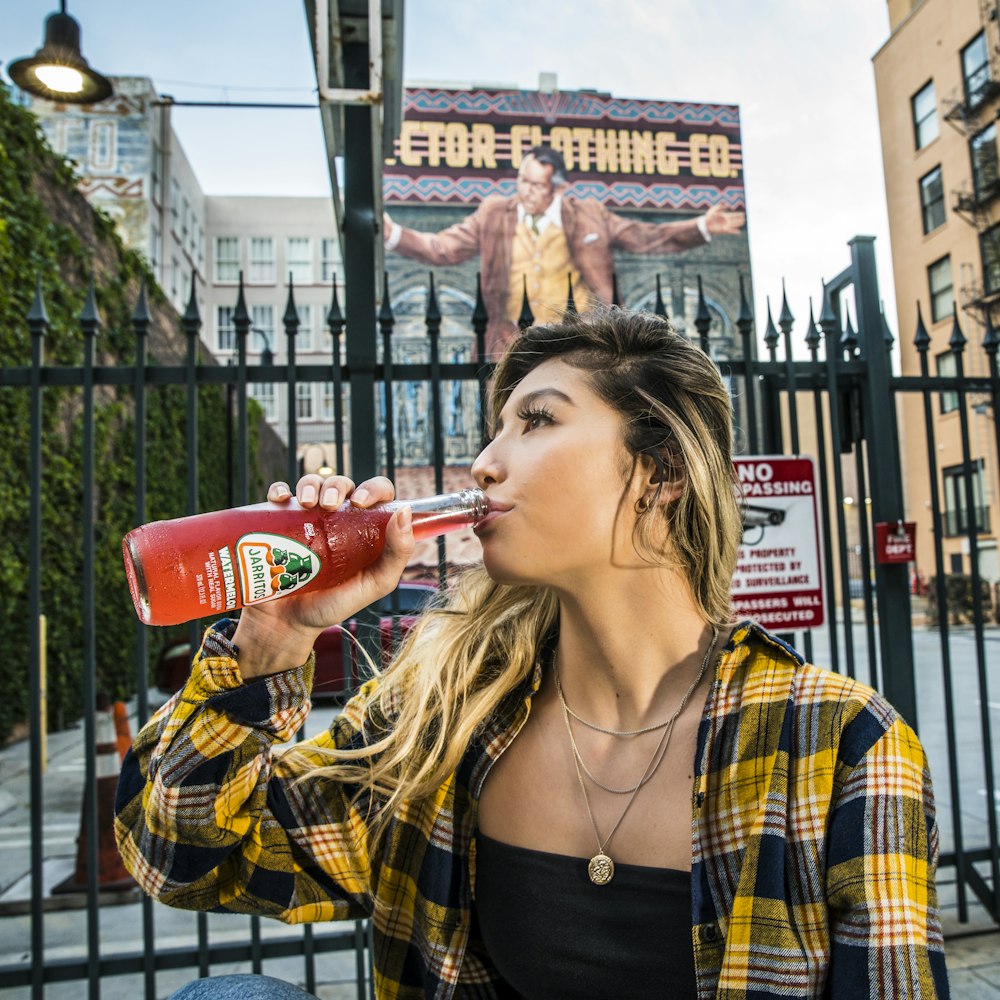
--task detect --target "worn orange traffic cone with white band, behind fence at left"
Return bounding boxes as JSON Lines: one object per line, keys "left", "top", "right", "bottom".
{"left": 52, "top": 698, "right": 135, "bottom": 893}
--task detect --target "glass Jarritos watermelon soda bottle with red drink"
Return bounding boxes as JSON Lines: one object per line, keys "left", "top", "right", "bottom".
{"left": 122, "top": 489, "right": 490, "bottom": 625}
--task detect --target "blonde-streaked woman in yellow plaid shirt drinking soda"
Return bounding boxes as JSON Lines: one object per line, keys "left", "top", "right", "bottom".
{"left": 117, "top": 309, "right": 947, "bottom": 1000}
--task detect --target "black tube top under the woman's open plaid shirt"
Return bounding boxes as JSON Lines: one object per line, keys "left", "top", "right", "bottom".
{"left": 475, "top": 833, "right": 697, "bottom": 1000}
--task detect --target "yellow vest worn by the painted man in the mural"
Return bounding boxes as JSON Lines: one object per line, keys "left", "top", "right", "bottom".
{"left": 507, "top": 222, "right": 594, "bottom": 323}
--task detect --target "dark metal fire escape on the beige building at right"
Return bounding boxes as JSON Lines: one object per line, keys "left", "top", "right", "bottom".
{"left": 944, "top": 0, "right": 1000, "bottom": 324}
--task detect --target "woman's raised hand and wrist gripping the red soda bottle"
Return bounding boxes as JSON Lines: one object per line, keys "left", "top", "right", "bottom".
{"left": 233, "top": 475, "right": 413, "bottom": 679}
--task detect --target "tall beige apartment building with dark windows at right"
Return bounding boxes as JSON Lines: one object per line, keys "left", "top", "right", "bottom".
{"left": 874, "top": 0, "right": 1000, "bottom": 582}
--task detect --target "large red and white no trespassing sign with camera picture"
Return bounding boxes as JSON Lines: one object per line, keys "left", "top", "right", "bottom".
{"left": 732, "top": 455, "right": 823, "bottom": 631}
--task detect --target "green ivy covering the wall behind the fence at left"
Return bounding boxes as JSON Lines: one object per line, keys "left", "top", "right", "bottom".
{"left": 0, "top": 85, "right": 270, "bottom": 743}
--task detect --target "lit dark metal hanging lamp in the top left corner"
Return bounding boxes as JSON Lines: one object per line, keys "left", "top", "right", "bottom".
{"left": 7, "top": 0, "right": 112, "bottom": 104}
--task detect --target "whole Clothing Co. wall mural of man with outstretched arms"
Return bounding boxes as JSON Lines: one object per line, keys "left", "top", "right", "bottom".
{"left": 383, "top": 88, "right": 750, "bottom": 466}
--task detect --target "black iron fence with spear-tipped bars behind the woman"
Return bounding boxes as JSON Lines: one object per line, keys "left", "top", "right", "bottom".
{"left": 0, "top": 238, "right": 1000, "bottom": 1000}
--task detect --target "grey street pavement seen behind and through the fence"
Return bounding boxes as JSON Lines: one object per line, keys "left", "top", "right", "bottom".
{"left": 0, "top": 628, "right": 1000, "bottom": 1000}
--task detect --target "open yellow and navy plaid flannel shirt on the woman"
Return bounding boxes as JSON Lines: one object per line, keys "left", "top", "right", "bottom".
{"left": 116, "top": 622, "right": 948, "bottom": 1000}
